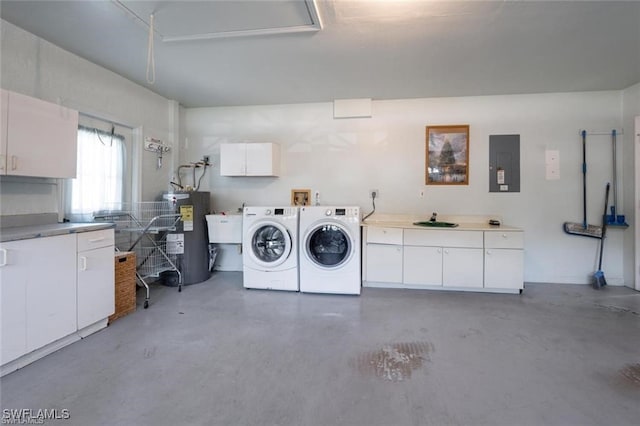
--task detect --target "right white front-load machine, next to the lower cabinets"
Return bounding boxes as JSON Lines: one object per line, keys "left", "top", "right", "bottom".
{"left": 299, "top": 206, "right": 361, "bottom": 294}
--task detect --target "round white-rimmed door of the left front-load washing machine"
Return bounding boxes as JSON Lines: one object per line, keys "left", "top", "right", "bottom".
{"left": 250, "top": 222, "right": 292, "bottom": 268}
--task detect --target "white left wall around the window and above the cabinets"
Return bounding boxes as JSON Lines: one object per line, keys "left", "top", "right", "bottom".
{"left": 0, "top": 20, "right": 178, "bottom": 215}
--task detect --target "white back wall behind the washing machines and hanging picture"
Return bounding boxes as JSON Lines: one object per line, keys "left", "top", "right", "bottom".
{"left": 180, "top": 91, "right": 627, "bottom": 284}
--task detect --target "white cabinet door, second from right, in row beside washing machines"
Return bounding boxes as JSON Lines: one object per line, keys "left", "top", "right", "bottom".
{"left": 442, "top": 247, "right": 484, "bottom": 288}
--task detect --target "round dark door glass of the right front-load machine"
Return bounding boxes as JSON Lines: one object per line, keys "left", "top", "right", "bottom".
{"left": 307, "top": 224, "right": 351, "bottom": 268}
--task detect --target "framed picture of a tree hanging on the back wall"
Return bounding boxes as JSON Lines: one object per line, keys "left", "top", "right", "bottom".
{"left": 425, "top": 124, "right": 469, "bottom": 185}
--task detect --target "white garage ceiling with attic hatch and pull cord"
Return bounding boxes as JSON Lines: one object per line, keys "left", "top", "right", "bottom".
{"left": 0, "top": 0, "right": 640, "bottom": 107}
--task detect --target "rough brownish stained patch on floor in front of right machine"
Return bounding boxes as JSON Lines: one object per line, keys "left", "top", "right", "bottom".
{"left": 352, "top": 342, "right": 434, "bottom": 382}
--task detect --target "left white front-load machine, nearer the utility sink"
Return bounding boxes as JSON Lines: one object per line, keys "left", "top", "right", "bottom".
{"left": 242, "top": 207, "right": 299, "bottom": 291}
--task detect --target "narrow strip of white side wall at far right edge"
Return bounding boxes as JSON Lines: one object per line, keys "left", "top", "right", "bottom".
{"left": 622, "top": 83, "right": 640, "bottom": 290}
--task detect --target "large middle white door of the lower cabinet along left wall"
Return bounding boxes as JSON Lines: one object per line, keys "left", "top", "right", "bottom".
{"left": 26, "top": 234, "right": 76, "bottom": 352}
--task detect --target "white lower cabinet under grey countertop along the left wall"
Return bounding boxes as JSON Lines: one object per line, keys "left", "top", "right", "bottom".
{"left": 0, "top": 229, "right": 115, "bottom": 374}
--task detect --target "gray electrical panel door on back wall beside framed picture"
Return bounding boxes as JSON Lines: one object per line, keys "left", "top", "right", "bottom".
{"left": 489, "top": 135, "right": 520, "bottom": 192}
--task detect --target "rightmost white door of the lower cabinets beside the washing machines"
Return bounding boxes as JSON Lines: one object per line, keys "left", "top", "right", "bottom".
{"left": 484, "top": 249, "right": 524, "bottom": 289}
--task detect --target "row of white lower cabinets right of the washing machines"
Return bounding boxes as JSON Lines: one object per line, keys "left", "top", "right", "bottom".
{"left": 363, "top": 226, "right": 524, "bottom": 293}
